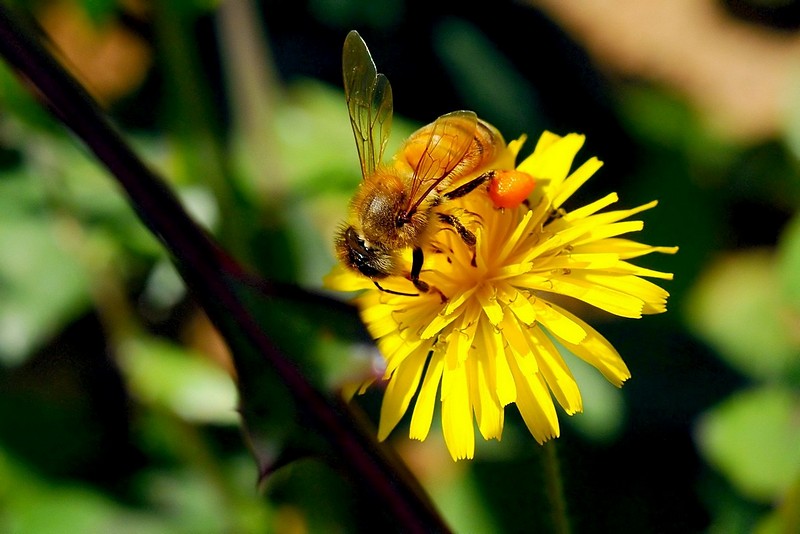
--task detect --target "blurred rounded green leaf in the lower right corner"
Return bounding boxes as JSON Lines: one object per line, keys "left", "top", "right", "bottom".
{"left": 696, "top": 386, "right": 800, "bottom": 503}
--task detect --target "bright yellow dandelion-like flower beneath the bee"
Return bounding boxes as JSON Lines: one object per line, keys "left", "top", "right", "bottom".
{"left": 326, "top": 132, "right": 677, "bottom": 460}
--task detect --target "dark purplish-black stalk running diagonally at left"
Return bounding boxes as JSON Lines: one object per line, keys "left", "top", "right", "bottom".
{"left": 0, "top": 4, "right": 448, "bottom": 532}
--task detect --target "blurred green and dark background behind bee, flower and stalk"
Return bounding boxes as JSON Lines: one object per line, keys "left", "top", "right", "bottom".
{"left": 0, "top": 0, "right": 800, "bottom": 533}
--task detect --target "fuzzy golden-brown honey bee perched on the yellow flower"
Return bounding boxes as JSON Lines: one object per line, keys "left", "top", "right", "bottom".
{"left": 335, "top": 31, "right": 506, "bottom": 296}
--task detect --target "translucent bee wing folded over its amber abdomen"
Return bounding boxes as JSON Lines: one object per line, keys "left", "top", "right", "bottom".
{"left": 405, "top": 110, "right": 478, "bottom": 215}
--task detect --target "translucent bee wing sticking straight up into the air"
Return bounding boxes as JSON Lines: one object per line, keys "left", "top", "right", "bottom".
{"left": 342, "top": 30, "right": 392, "bottom": 178}
